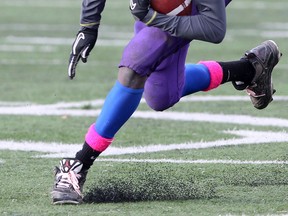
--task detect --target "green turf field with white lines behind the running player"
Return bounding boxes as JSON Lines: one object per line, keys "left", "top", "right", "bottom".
{"left": 0, "top": 0, "right": 288, "bottom": 216}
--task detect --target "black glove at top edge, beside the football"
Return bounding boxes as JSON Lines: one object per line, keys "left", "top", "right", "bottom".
{"left": 130, "top": 0, "right": 150, "bottom": 21}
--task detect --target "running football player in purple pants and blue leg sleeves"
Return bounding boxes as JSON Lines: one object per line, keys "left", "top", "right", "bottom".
{"left": 52, "top": 0, "right": 280, "bottom": 204}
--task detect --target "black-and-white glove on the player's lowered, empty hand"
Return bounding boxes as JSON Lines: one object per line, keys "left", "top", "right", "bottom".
{"left": 68, "top": 28, "right": 98, "bottom": 79}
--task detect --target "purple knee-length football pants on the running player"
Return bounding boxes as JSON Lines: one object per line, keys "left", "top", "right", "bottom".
{"left": 119, "top": 22, "right": 189, "bottom": 111}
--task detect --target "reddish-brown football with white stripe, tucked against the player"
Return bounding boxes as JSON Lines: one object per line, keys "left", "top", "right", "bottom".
{"left": 150, "top": 0, "right": 192, "bottom": 16}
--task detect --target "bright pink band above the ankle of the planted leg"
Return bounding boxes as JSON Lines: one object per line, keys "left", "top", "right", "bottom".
{"left": 85, "top": 123, "right": 114, "bottom": 152}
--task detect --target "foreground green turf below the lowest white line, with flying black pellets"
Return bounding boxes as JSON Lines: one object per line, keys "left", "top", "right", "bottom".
{"left": 0, "top": 151, "right": 288, "bottom": 215}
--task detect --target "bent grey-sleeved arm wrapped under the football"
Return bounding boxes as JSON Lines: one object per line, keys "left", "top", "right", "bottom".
{"left": 132, "top": 0, "right": 230, "bottom": 43}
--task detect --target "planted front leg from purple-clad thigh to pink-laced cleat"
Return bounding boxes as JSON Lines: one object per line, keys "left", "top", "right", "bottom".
{"left": 52, "top": 23, "right": 182, "bottom": 204}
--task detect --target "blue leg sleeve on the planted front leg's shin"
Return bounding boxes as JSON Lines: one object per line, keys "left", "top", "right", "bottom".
{"left": 95, "top": 81, "right": 144, "bottom": 138}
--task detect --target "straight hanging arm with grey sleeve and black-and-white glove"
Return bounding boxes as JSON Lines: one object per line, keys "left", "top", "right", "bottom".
{"left": 68, "top": 0, "right": 106, "bottom": 79}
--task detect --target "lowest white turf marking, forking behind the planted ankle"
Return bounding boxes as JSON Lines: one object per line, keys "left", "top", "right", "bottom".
{"left": 0, "top": 130, "right": 288, "bottom": 165}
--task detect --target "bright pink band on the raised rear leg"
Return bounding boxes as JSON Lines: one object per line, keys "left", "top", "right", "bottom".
{"left": 198, "top": 61, "right": 223, "bottom": 91}
